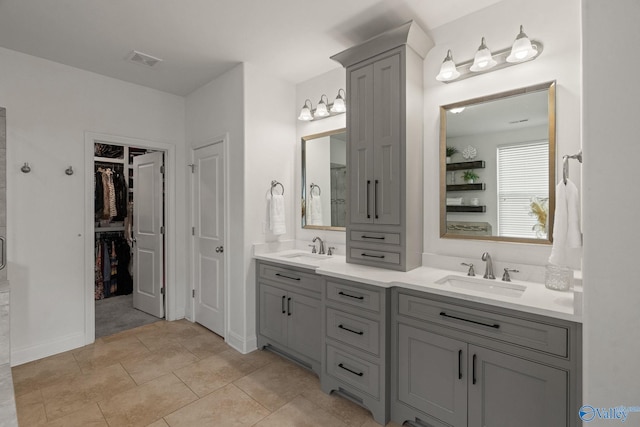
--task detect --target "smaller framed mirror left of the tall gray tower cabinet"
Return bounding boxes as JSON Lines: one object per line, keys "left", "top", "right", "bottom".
{"left": 301, "top": 128, "right": 347, "bottom": 231}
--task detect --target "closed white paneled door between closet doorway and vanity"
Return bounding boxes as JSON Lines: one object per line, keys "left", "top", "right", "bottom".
{"left": 192, "top": 142, "right": 225, "bottom": 336}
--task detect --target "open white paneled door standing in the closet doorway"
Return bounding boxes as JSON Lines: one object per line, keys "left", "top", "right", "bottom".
{"left": 133, "top": 152, "right": 164, "bottom": 317}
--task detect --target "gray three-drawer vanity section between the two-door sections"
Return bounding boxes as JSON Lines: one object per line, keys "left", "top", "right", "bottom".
{"left": 320, "top": 278, "right": 389, "bottom": 425}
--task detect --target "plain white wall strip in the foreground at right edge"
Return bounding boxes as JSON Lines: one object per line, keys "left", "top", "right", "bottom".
{"left": 582, "top": 0, "right": 640, "bottom": 414}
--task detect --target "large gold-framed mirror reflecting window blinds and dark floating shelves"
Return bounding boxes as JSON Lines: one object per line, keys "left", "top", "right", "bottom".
{"left": 440, "top": 82, "right": 556, "bottom": 244}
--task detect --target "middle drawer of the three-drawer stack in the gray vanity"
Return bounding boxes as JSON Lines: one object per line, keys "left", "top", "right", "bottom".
{"left": 327, "top": 308, "right": 380, "bottom": 356}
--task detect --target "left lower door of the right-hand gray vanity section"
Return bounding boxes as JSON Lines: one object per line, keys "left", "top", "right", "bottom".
{"left": 398, "top": 323, "right": 468, "bottom": 426}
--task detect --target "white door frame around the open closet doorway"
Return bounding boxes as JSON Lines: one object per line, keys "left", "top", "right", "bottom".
{"left": 84, "top": 131, "right": 177, "bottom": 345}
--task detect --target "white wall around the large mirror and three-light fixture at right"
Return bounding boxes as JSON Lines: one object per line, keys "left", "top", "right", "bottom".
{"left": 424, "top": 0, "right": 580, "bottom": 264}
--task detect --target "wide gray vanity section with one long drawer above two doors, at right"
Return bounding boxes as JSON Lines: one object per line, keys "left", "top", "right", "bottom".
{"left": 391, "top": 289, "right": 581, "bottom": 427}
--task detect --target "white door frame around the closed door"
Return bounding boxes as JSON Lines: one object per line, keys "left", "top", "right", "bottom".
{"left": 188, "top": 133, "right": 231, "bottom": 342}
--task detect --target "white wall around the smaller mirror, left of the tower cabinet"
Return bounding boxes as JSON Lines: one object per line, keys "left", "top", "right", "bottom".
{"left": 294, "top": 68, "right": 349, "bottom": 249}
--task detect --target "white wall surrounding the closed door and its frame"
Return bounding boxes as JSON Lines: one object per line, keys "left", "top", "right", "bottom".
{"left": 185, "top": 64, "right": 246, "bottom": 350}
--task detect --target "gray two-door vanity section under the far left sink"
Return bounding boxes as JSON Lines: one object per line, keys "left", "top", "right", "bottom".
{"left": 256, "top": 261, "right": 322, "bottom": 375}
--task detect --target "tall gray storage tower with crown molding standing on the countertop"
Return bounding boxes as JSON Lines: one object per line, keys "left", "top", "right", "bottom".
{"left": 332, "top": 21, "right": 433, "bottom": 271}
